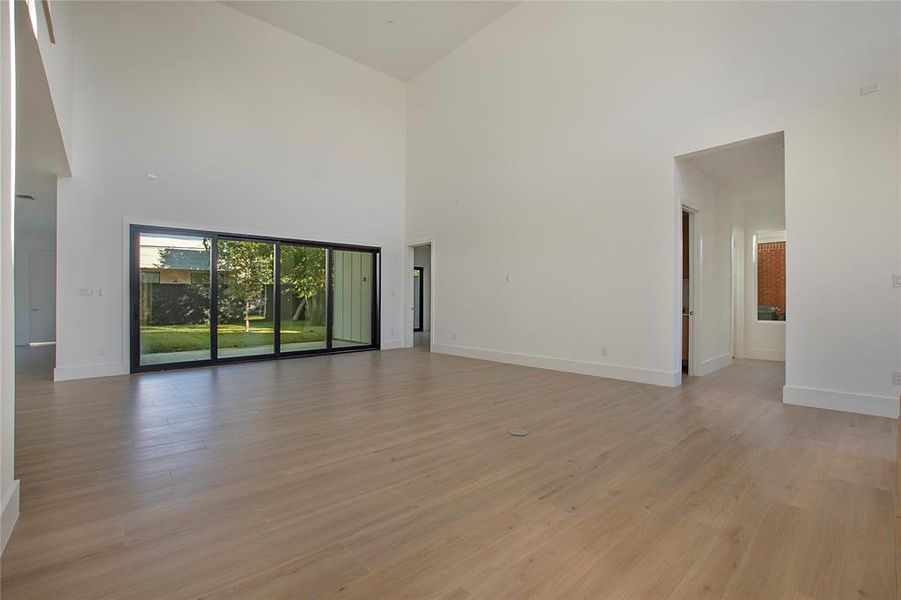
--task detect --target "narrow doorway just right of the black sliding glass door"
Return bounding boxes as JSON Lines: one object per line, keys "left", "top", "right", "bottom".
{"left": 404, "top": 241, "right": 435, "bottom": 350}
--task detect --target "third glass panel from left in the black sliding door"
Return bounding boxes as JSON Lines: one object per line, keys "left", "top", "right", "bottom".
{"left": 279, "top": 244, "right": 328, "bottom": 352}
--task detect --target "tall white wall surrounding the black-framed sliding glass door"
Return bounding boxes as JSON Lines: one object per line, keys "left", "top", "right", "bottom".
{"left": 56, "top": 2, "right": 405, "bottom": 379}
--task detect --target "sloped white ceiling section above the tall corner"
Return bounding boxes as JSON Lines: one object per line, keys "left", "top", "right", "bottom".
{"left": 224, "top": 0, "right": 517, "bottom": 81}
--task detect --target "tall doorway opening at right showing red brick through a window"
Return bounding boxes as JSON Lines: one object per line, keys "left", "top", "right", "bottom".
{"left": 675, "top": 132, "right": 791, "bottom": 376}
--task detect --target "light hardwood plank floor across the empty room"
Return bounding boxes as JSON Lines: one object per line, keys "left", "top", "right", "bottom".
{"left": 2, "top": 350, "right": 899, "bottom": 600}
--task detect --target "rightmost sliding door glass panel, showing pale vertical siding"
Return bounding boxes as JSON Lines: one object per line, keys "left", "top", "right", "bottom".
{"left": 332, "top": 250, "right": 374, "bottom": 348}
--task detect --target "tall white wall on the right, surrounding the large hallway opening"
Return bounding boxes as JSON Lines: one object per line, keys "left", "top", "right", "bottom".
{"left": 406, "top": 3, "right": 901, "bottom": 414}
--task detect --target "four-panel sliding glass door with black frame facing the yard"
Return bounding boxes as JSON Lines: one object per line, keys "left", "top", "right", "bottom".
{"left": 131, "top": 225, "right": 380, "bottom": 372}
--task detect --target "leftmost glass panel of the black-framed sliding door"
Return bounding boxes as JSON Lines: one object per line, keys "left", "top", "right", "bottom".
{"left": 139, "top": 233, "right": 210, "bottom": 365}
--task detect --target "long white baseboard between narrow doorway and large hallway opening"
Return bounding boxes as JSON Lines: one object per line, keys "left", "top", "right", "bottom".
{"left": 432, "top": 343, "right": 681, "bottom": 387}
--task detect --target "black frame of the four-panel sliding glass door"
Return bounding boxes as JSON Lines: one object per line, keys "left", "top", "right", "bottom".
{"left": 129, "top": 224, "right": 382, "bottom": 373}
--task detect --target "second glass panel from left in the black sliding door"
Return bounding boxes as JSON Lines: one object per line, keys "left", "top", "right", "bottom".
{"left": 217, "top": 238, "right": 275, "bottom": 358}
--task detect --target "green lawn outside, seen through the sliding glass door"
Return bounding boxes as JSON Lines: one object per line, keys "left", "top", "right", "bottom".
{"left": 141, "top": 321, "right": 325, "bottom": 354}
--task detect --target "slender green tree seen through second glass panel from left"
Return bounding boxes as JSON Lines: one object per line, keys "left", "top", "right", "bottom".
{"left": 218, "top": 240, "right": 274, "bottom": 332}
